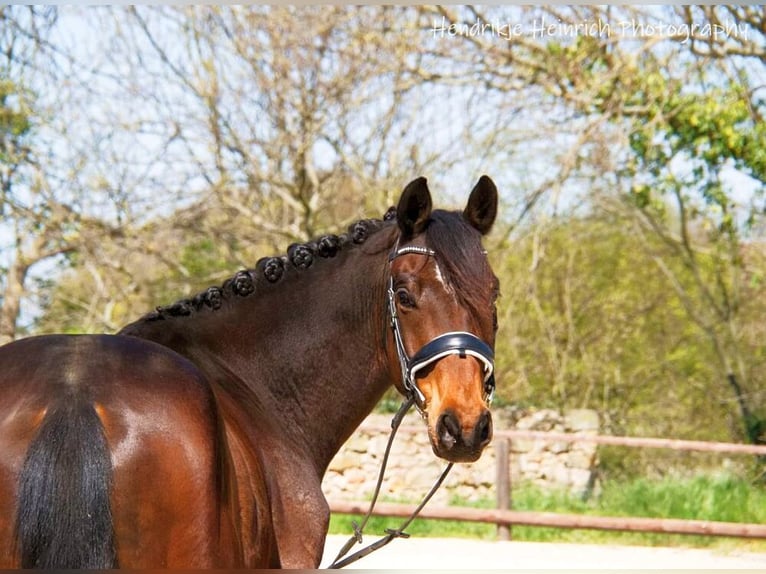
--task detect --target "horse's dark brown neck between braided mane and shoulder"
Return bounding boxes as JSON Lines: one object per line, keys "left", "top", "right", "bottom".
{"left": 125, "top": 241, "right": 391, "bottom": 472}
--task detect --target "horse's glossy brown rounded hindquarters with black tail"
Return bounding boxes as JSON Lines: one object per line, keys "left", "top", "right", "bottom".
{"left": 0, "top": 335, "right": 242, "bottom": 568}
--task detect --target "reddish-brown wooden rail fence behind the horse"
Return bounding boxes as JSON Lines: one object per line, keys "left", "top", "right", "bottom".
{"left": 330, "top": 427, "right": 766, "bottom": 539}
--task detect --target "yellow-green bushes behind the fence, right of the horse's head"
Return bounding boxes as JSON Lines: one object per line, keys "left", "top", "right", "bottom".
{"left": 490, "top": 206, "right": 766, "bottom": 454}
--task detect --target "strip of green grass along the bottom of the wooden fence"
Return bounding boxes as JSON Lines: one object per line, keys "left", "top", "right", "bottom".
{"left": 330, "top": 475, "right": 766, "bottom": 552}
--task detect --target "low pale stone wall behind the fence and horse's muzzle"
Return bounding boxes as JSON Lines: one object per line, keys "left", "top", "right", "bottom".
{"left": 323, "top": 409, "right": 599, "bottom": 505}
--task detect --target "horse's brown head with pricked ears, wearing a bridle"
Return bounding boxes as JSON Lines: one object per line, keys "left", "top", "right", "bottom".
{"left": 389, "top": 176, "right": 498, "bottom": 462}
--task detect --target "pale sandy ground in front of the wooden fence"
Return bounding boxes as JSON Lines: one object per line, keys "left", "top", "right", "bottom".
{"left": 322, "top": 536, "right": 766, "bottom": 573}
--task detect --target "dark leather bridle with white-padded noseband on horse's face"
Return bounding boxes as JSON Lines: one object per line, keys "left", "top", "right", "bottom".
{"left": 388, "top": 244, "right": 495, "bottom": 413}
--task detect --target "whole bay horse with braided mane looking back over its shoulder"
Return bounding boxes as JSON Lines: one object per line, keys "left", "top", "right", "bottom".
{"left": 0, "top": 176, "right": 498, "bottom": 569}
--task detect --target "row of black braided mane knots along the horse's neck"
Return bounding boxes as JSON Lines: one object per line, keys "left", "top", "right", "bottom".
{"left": 141, "top": 212, "right": 396, "bottom": 321}
